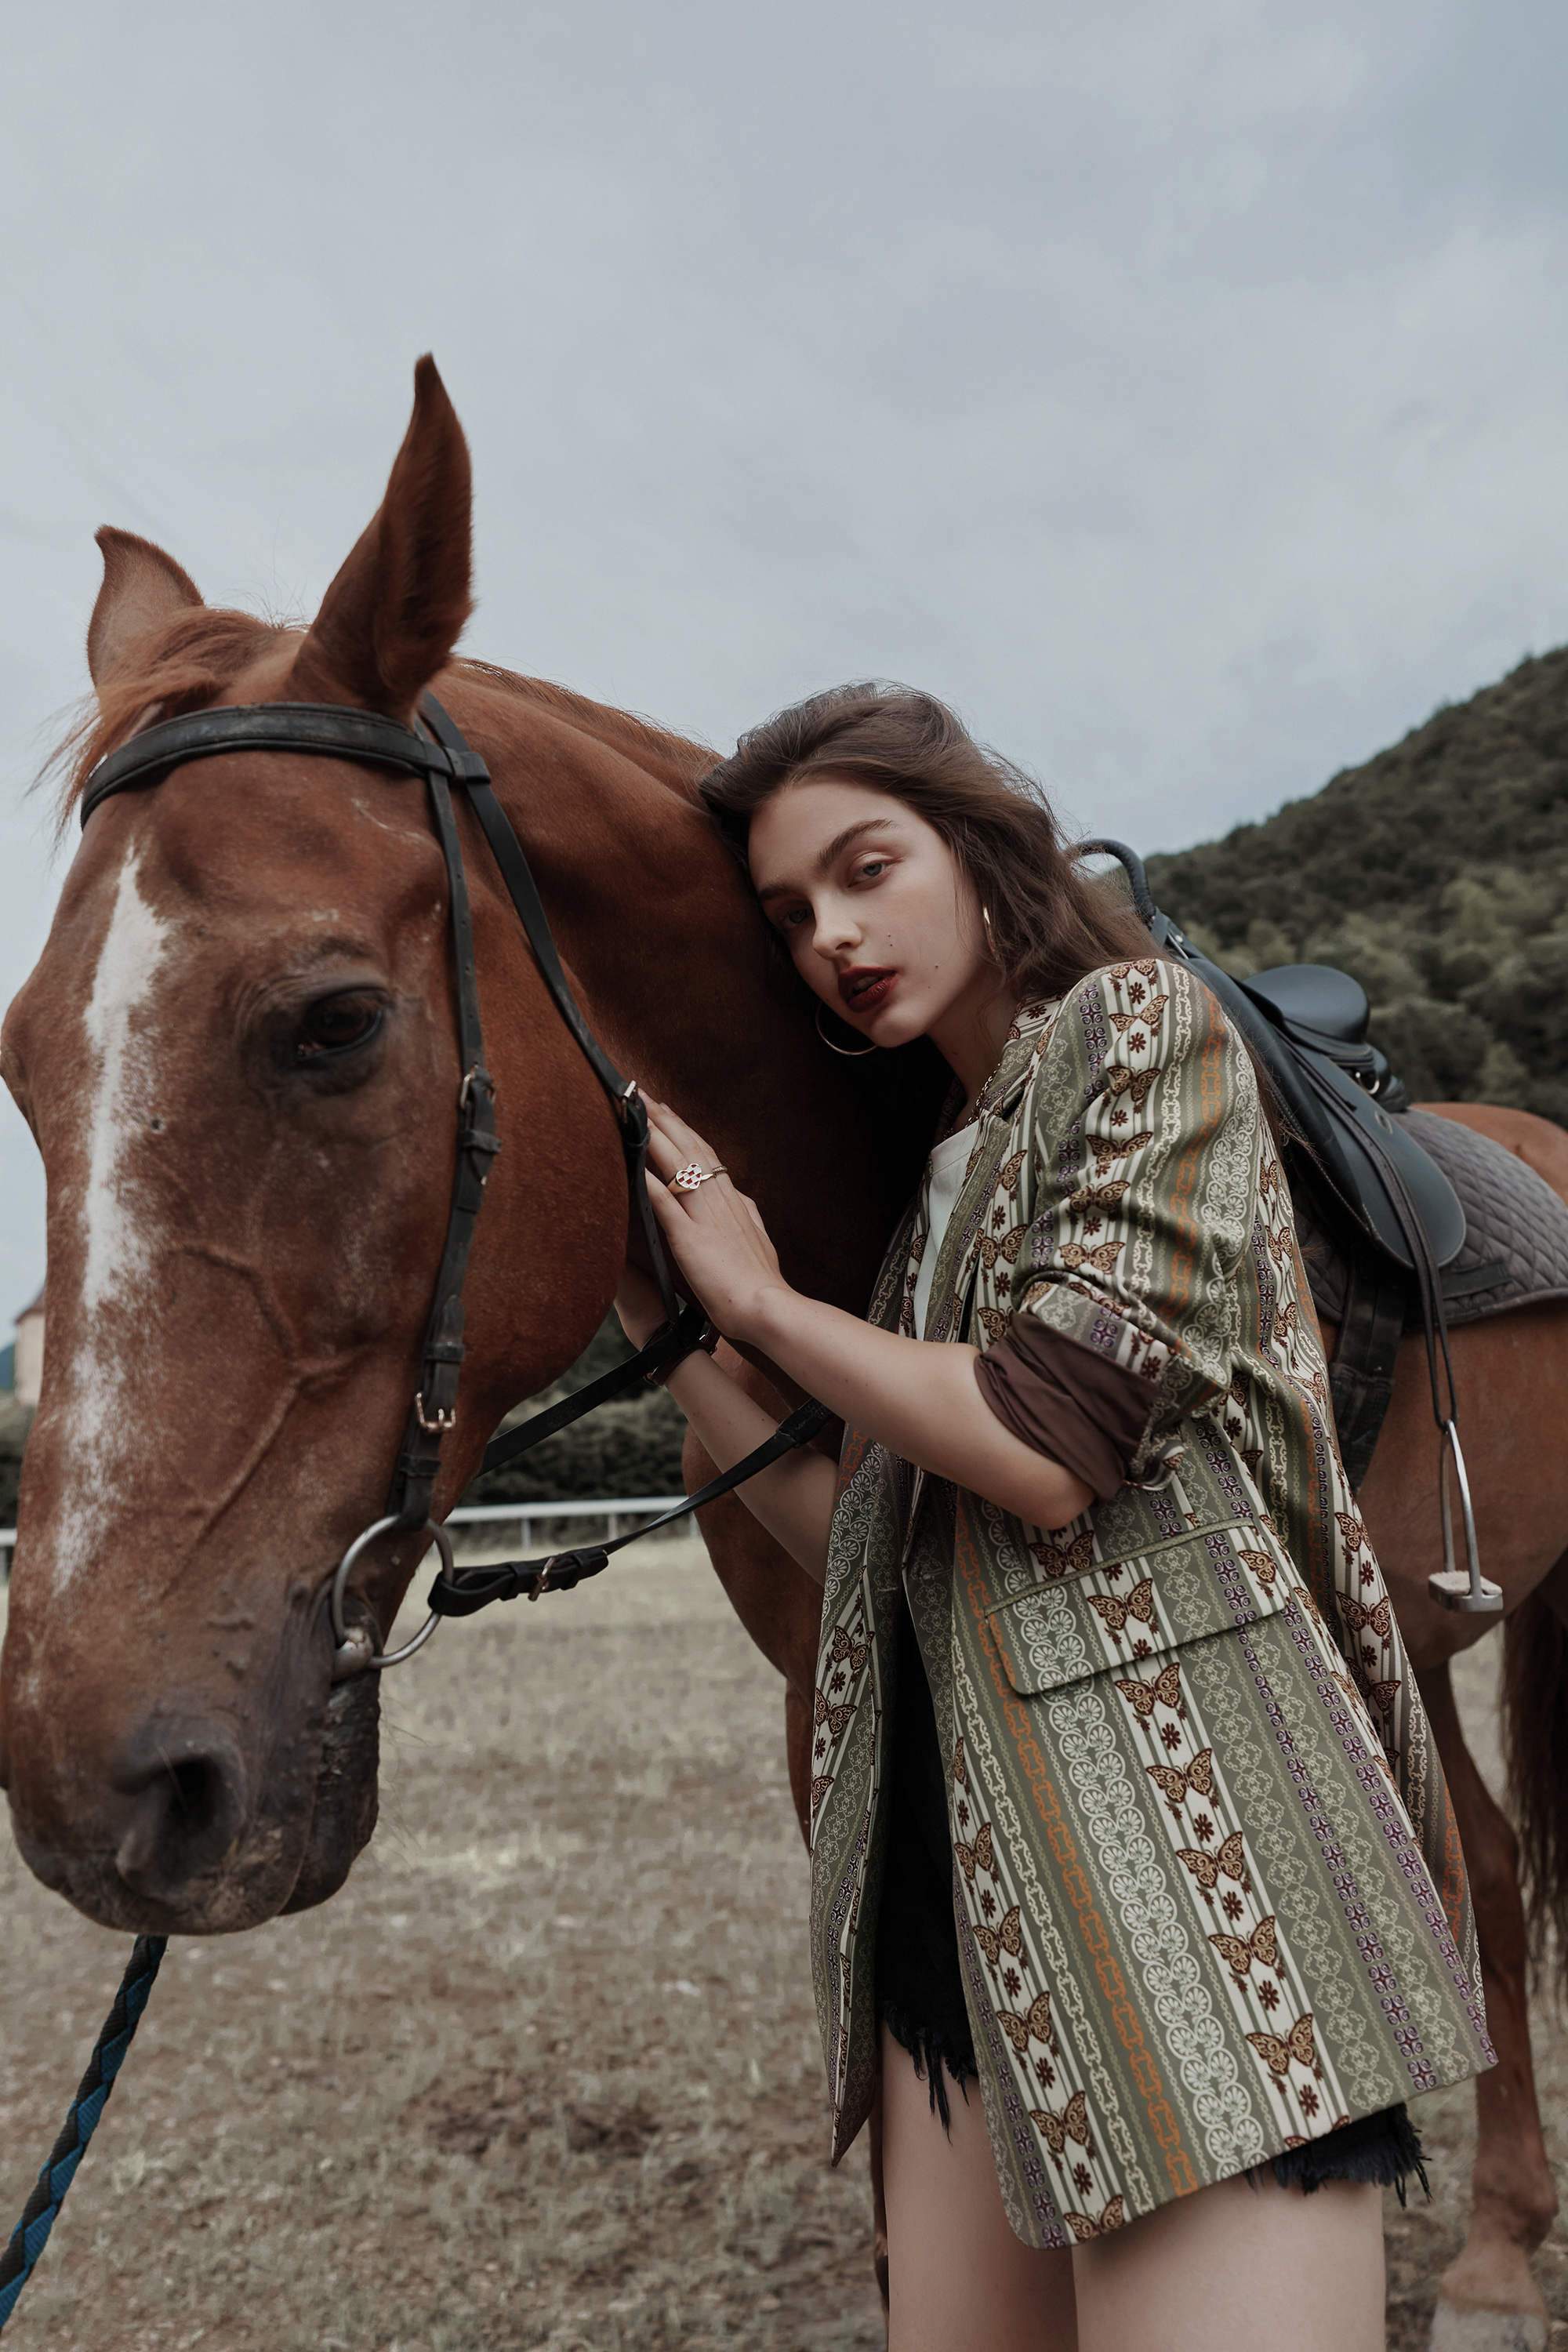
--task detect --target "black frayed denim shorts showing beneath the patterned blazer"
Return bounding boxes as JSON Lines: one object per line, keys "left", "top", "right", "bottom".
{"left": 877, "top": 1595, "right": 1432, "bottom": 2204}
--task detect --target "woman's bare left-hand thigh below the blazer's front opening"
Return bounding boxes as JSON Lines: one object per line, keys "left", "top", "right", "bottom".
{"left": 881, "top": 2025, "right": 1081, "bottom": 2352}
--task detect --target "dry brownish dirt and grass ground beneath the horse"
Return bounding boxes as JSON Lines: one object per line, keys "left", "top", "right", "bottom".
{"left": 0, "top": 1538, "right": 1568, "bottom": 2352}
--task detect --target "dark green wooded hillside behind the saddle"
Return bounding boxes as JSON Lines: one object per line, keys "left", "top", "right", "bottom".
{"left": 1149, "top": 649, "right": 1568, "bottom": 1124}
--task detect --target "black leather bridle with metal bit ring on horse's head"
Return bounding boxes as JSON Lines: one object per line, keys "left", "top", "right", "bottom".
{"left": 80, "top": 694, "right": 832, "bottom": 1677}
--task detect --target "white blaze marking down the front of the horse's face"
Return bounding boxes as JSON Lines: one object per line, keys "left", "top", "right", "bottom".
{"left": 52, "top": 842, "right": 169, "bottom": 1588}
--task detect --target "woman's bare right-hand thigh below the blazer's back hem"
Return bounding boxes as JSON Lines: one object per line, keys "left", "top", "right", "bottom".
{"left": 1072, "top": 2173, "right": 1387, "bottom": 2352}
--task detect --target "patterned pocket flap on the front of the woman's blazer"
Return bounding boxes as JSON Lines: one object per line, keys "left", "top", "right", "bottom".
{"left": 987, "top": 1522, "right": 1302, "bottom": 1691}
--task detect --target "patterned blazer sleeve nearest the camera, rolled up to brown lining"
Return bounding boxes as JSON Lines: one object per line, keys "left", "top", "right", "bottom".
{"left": 975, "top": 957, "right": 1260, "bottom": 1496}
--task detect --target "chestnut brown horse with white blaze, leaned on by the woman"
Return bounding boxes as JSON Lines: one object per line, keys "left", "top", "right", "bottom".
{"left": 0, "top": 362, "right": 1568, "bottom": 2347}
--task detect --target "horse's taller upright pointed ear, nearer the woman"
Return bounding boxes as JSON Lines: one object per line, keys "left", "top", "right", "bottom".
{"left": 289, "top": 353, "right": 473, "bottom": 720}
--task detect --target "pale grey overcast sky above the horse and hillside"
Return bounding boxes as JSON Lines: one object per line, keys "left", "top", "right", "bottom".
{"left": 0, "top": 0, "right": 1568, "bottom": 1338}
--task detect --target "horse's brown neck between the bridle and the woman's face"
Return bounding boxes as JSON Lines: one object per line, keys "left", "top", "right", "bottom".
{"left": 465, "top": 689, "right": 898, "bottom": 1312}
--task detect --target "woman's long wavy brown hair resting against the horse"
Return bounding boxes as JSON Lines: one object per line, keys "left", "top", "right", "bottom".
{"left": 696, "top": 680, "right": 1279, "bottom": 1141}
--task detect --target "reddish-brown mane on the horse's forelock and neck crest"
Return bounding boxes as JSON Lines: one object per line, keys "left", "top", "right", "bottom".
{"left": 35, "top": 604, "right": 715, "bottom": 840}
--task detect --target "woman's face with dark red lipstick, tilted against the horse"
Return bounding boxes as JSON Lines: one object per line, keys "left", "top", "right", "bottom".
{"left": 746, "top": 776, "right": 996, "bottom": 1047}
